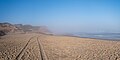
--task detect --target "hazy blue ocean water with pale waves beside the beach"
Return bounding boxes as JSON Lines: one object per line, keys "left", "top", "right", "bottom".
{"left": 74, "top": 33, "right": 120, "bottom": 41}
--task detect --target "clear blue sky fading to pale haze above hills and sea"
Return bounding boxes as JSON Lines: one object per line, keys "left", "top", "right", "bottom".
{"left": 0, "top": 0, "right": 120, "bottom": 33}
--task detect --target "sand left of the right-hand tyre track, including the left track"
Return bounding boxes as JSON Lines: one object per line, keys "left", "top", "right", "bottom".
{"left": 0, "top": 34, "right": 40, "bottom": 60}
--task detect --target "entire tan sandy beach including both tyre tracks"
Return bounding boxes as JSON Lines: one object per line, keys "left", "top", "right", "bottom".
{"left": 0, "top": 33, "right": 120, "bottom": 60}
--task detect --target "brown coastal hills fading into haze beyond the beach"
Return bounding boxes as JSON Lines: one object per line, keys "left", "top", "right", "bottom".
{"left": 0, "top": 23, "right": 50, "bottom": 36}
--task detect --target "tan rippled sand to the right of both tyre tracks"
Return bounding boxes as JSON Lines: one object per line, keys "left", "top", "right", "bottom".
{"left": 42, "top": 36, "right": 120, "bottom": 60}
